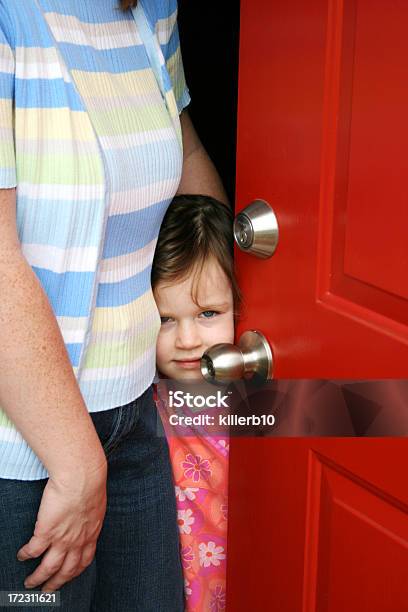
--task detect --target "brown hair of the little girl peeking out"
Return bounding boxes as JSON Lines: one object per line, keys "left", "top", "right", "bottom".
{"left": 152, "top": 195, "right": 241, "bottom": 311}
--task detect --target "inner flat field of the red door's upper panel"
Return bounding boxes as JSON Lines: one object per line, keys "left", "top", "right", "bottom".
{"left": 338, "top": 0, "right": 408, "bottom": 299}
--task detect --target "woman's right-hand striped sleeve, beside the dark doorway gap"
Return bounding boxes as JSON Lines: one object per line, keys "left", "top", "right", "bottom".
{"left": 156, "top": 0, "right": 190, "bottom": 113}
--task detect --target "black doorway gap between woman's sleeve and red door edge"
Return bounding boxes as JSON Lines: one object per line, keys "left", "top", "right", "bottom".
{"left": 178, "top": 0, "right": 240, "bottom": 205}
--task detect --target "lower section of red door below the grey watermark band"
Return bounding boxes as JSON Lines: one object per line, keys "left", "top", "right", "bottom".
{"left": 227, "top": 438, "right": 408, "bottom": 612}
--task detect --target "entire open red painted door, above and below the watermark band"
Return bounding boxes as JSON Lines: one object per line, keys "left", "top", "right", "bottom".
{"left": 228, "top": 0, "right": 408, "bottom": 612}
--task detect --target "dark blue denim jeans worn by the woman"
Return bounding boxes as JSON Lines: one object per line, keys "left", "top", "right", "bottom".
{"left": 0, "top": 388, "right": 184, "bottom": 612}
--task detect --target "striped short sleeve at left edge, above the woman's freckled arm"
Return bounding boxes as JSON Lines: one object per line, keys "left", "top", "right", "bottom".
{"left": 0, "top": 22, "right": 17, "bottom": 189}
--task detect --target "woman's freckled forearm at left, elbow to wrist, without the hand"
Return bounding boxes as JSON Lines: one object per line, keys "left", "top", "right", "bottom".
{"left": 0, "top": 248, "right": 105, "bottom": 478}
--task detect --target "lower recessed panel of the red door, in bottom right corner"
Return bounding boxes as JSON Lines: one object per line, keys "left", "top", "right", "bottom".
{"left": 304, "top": 442, "right": 408, "bottom": 612}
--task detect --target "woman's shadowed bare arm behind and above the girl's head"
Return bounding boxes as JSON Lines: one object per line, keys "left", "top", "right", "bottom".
{"left": 177, "top": 110, "right": 228, "bottom": 204}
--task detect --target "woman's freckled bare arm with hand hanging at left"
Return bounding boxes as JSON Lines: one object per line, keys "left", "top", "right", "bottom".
{"left": 0, "top": 189, "right": 106, "bottom": 589}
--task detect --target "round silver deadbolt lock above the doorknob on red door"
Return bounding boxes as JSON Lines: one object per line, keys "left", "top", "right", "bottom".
{"left": 234, "top": 200, "right": 279, "bottom": 259}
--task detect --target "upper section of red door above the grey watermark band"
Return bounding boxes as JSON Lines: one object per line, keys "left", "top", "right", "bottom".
{"left": 237, "top": 0, "right": 408, "bottom": 378}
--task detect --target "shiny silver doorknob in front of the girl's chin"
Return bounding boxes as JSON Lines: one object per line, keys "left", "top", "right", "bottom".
{"left": 201, "top": 330, "right": 273, "bottom": 383}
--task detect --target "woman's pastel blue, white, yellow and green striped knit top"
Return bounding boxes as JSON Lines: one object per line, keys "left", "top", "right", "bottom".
{"left": 0, "top": 0, "right": 189, "bottom": 480}
